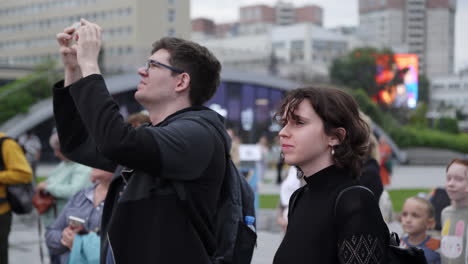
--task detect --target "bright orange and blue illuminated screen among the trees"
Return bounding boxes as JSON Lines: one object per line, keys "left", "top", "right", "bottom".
{"left": 374, "top": 54, "right": 418, "bottom": 108}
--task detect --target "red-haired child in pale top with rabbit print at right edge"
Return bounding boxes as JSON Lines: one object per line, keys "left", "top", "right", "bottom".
{"left": 441, "top": 159, "right": 468, "bottom": 264}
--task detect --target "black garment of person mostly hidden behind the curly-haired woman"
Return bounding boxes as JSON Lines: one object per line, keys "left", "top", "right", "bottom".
{"left": 359, "top": 158, "right": 383, "bottom": 200}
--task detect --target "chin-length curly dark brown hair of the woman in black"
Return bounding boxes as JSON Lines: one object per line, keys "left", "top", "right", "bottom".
{"left": 275, "top": 87, "right": 370, "bottom": 179}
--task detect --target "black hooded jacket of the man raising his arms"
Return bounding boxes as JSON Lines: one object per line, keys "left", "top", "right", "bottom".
{"left": 54, "top": 74, "right": 230, "bottom": 264}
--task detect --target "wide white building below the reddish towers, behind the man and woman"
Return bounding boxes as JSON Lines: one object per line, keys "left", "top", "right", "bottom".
{"left": 197, "top": 23, "right": 362, "bottom": 79}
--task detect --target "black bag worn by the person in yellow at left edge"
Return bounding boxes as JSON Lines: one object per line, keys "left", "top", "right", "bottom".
{"left": 0, "top": 137, "right": 34, "bottom": 214}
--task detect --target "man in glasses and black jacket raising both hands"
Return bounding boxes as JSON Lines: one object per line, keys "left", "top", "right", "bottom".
{"left": 53, "top": 19, "right": 225, "bottom": 264}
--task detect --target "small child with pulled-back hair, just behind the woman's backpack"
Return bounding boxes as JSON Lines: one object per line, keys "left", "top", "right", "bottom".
{"left": 400, "top": 197, "right": 440, "bottom": 264}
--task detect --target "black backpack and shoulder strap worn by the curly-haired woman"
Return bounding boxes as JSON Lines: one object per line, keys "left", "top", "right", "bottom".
{"left": 334, "top": 185, "right": 427, "bottom": 264}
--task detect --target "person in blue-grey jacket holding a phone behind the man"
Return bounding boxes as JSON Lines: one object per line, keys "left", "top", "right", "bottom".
{"left": 45, "top": 169, "right": 113, "bottom": 264}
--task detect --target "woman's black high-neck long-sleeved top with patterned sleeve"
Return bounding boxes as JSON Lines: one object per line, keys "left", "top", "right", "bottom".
{"left": 273, "top": 165, "right": 389, "bottom": 264}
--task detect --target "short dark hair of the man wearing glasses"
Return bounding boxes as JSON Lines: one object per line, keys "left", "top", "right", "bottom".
{"left": 151, "top": 37, "right": 221, "bottom": 105}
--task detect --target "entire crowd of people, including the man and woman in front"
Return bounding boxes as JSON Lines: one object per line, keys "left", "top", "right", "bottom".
{"left": 0, "top": 19, "right": 468, "bottom": 264}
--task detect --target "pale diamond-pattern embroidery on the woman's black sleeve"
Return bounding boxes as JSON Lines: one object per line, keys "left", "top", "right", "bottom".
{"left": 338, "top": 234, "right": 385, "bottom": 264}
